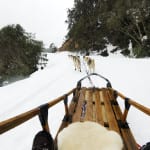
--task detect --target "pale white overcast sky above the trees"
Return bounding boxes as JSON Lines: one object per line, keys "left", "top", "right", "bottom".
{"left": 0, "top": 0, "right": 74, "bottom": 47}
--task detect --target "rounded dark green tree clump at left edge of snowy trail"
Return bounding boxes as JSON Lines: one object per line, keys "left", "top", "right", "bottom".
{"left": 0, "top": 24, "right": 43, "bottom": 85}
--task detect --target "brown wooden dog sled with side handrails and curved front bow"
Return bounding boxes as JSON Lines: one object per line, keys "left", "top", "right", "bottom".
{"left": 0, "top": 73, "right": 150, "bottom": 150}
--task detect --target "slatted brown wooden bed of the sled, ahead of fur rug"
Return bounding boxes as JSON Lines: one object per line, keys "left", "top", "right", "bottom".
{"left": 59, "top": 87, "right": 138, "bottom": 150}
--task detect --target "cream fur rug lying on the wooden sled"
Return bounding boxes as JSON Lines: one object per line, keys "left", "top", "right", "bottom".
{"left": 58, "top": 121, "right": 123, "bottom": 150}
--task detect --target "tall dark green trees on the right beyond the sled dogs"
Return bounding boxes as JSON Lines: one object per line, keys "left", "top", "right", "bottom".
{"left": 66, "top": 0, "right": 150, "bottom": 58}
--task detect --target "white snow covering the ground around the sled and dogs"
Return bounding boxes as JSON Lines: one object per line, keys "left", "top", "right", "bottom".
{"left": 0, "top": 52, "right": 150, "bottom": 150}
